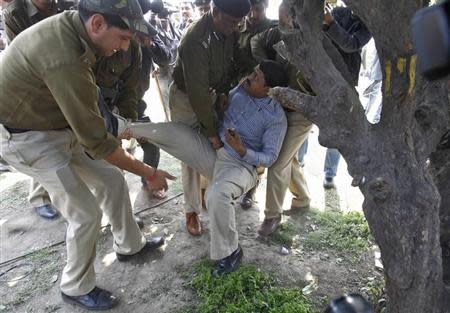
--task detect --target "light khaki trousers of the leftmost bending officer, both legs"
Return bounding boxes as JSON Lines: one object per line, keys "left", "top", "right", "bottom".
{"left": 0, "top": 124, "right": 145, "bottom": 296}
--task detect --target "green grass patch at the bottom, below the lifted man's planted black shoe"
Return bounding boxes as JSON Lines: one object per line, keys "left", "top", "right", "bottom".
{"left": 183, "top": 262, "right": 312, "bottom": 313}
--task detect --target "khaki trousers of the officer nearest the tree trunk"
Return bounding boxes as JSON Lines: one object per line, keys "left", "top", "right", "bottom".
{"left": 264, "top": 112, "right": 312, "bottom": 218}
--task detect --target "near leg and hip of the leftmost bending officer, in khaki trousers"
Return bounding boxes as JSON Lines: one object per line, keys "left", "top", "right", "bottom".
{"left": 0, "top": 130, "right": 101, "bottom": 296}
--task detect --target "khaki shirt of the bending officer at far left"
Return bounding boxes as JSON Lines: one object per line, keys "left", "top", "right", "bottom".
{"left": 0, "top": 11, "right": 119, "bottom": 159}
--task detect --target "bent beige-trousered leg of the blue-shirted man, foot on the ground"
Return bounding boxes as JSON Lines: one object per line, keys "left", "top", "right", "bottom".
{"left": 206, "top": 148, "right": 257, "bottom": 260}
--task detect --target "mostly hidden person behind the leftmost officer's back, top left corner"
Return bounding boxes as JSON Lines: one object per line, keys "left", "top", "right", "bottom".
{"left": 3, "top": 0, "right": 59, "bottom": 219}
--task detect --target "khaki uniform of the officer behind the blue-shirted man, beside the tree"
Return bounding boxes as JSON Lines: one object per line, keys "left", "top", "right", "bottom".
{"left": 251, "top": 27, "right": 313, "bottom": 218}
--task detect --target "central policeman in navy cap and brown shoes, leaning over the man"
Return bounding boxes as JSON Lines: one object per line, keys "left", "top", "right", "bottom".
{"left": 169, "top": 0, "right": 250, "bottom": 236}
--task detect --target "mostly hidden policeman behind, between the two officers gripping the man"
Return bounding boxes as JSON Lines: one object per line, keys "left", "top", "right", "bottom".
{"left": 234, "top": 0, "right": 276, "bottom": 209}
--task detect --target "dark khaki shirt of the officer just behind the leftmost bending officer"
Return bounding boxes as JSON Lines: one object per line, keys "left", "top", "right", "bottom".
{"left": 94, "top": 41, "right": 142, "bottom": 120}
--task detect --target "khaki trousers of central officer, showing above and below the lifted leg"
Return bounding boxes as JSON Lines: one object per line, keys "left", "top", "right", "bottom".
{"left": 169, "top": 83, "right": 207, "bottom": 214}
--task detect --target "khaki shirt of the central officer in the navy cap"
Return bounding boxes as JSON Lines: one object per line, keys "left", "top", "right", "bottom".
{"left": 173, "top": 12, "right": 234, "bottom": 137}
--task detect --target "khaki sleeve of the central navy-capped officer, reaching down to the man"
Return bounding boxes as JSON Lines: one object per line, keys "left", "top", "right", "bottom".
{"left": 179, "top": 40, "right": 217, "bottom": 137}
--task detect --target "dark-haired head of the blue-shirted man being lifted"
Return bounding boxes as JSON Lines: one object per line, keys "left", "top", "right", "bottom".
{"left": 243, "top": 60, "right": 288, "bottom": 98}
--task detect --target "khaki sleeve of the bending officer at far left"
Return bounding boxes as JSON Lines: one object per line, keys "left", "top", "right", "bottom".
{"left": 43, "top": 62, "right": 120, "bottom": 160}
